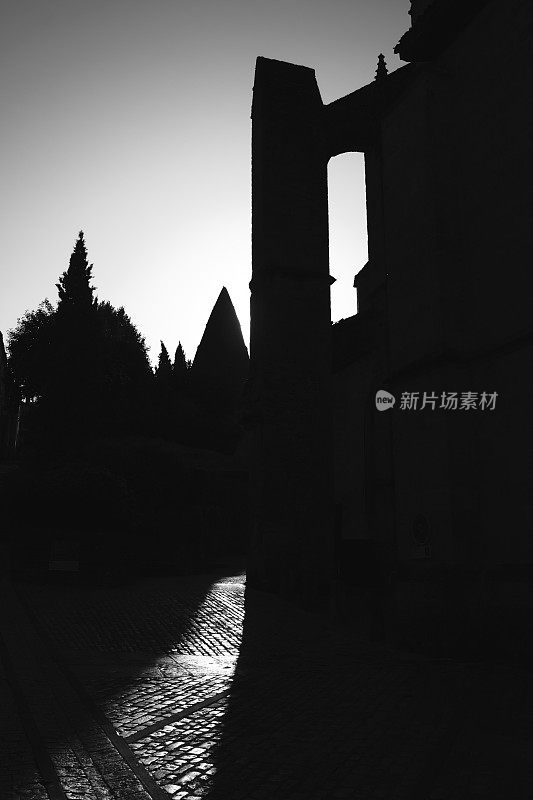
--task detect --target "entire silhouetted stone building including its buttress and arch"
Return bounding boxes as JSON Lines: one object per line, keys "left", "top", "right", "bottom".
{"left": 250, "top": 0, "right": 533, "bottom": 640}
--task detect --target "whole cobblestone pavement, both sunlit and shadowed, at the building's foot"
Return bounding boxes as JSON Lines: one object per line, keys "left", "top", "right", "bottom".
{"left": 0, "top": 575, "right": 533, "bottom": 800}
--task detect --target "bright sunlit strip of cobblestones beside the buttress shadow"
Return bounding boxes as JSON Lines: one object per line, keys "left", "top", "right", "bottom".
{"left": 128, "top": 576, "right": 244, "bottom": 800}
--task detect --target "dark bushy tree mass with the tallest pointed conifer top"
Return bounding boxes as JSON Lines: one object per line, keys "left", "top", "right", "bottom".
{"left": 9, "top": 232, "right": 152, "bottom": 450}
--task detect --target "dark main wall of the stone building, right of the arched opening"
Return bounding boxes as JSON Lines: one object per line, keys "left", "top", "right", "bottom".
{"left": 372, "top": 0, "right": 533, "bottom": 642}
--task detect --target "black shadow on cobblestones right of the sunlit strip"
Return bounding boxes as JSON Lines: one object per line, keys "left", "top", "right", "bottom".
{"left": 206, "top": 592, "right": 531, "bottom": 800}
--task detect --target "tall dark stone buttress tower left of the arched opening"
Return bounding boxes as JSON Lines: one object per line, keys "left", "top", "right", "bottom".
{"left": 248, "top": 58, "right": 332, "bottom": 606}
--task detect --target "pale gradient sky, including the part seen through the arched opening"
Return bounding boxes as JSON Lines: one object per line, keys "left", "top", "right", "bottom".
{"left": 0, "top": 0, "right": 410, "bottom": 361}
